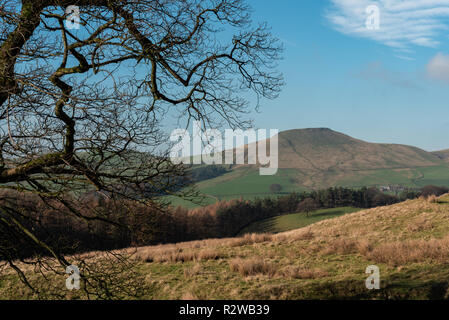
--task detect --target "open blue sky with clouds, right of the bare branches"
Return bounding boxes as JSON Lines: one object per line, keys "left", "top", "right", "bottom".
{"left": 243, "top": 0, "right": 449, "bottom": 151}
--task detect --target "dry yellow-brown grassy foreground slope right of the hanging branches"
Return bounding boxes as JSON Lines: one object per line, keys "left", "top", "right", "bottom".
{"left": 4, "top": 196, "right": 449, "bottom": 299}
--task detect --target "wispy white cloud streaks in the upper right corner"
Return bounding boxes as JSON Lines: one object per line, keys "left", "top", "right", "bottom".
{"left": 326, "top": 0, "right": 449, "bottom": 51}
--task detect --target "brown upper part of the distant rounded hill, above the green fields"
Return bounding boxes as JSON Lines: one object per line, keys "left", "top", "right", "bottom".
{"left": 270, "top": 128, "right": 440, "bottom": 171}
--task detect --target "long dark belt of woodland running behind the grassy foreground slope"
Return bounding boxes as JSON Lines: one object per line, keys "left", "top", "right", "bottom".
{"left": 0, "top": 186, "right": 440, "bottom": 256}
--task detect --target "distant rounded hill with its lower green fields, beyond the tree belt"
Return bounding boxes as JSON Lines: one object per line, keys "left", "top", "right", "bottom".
{"left": 176, "top": 128, "right": 449, "bottom": 205}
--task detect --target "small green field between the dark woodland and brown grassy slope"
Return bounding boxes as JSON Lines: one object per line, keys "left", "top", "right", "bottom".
{"left": 240, "top": 207, "right": 362, "bottom": 235}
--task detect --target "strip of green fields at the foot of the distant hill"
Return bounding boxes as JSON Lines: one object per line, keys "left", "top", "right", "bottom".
{"left": 164, "top": 164, "right": 449, "bottom": 208}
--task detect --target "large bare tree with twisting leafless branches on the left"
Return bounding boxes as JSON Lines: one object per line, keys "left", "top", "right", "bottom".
{"left": 0, "top": 0, "right": 282, "bottom": 298}
